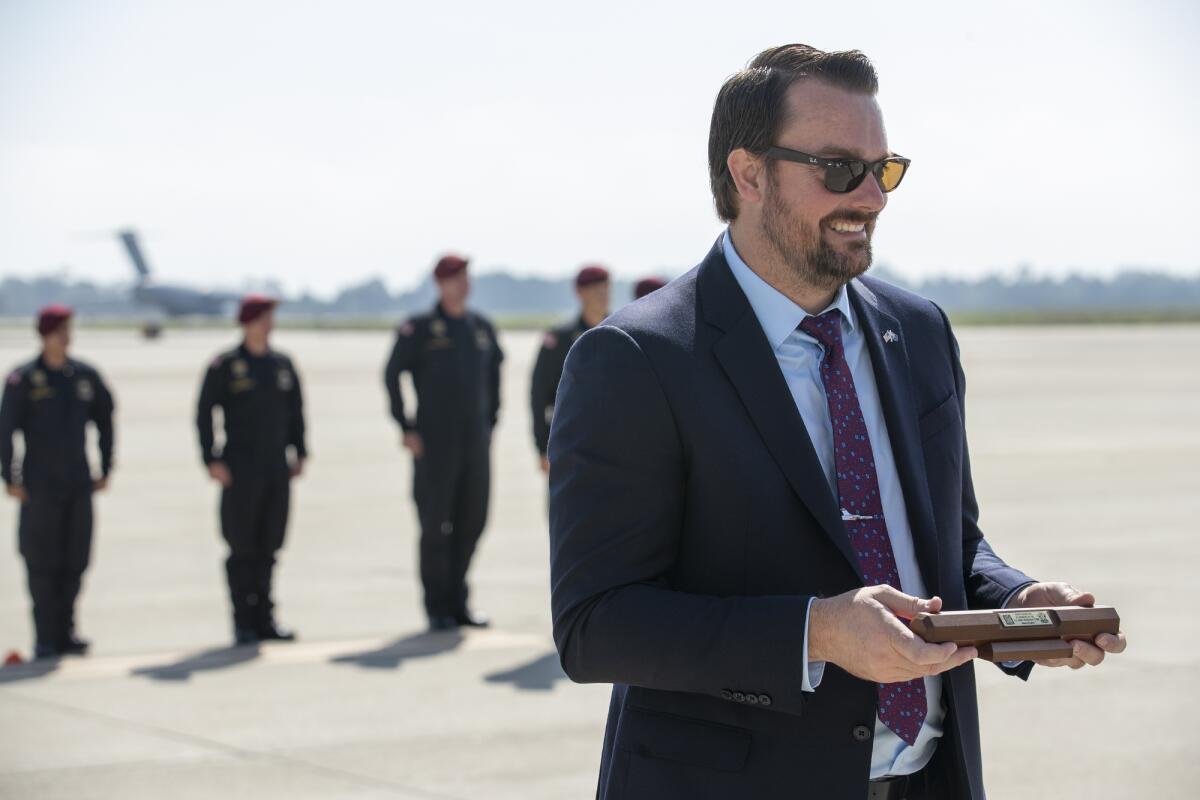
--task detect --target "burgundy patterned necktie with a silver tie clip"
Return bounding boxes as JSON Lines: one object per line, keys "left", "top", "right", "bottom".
{"left": 800, "top": 311, "right": 926, "bottom": 746}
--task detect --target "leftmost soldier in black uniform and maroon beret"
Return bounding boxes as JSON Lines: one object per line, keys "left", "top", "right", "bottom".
{"left": 0, "top": 306, "right": 113, "bottom": 658}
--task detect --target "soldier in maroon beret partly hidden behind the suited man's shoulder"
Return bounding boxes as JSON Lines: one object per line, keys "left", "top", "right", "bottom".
{"left": 529, "top": 264, "right": 608, "bottom": 473}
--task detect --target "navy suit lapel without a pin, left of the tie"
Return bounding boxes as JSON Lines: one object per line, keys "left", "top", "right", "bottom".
{"left": 700, "top": 242, "right": 862, "bottom": 579}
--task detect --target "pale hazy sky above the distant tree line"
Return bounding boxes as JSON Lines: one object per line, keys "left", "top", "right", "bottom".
{"left": 0, "top": 0, "right": 1200, "bottom": 294}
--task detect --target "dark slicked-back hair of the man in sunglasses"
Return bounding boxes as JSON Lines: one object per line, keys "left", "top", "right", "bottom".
{"left": 708, "top": 44, "right": 880, "bottom": 222}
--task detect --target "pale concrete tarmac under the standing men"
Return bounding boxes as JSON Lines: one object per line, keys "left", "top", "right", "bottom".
{"left": 0, "top": 326, "right": 1200, "bottom": 800}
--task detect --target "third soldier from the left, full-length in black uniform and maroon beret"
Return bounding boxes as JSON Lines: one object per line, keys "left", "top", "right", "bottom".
{"left": 384, "top": 255, "right": 504, "bottom": 631}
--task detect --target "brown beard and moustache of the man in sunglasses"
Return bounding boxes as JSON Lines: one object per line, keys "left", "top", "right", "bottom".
{"left": 762, "top": 184, "right": 876, "bottom": 290}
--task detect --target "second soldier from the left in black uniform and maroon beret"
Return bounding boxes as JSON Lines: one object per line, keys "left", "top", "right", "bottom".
{"left": 196, "top": 295, "right": 308, "bottom": 644}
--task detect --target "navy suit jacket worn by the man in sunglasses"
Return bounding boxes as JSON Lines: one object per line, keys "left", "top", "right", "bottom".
{"left": 550, "top": 242, "right": 1030, "bottom": 800}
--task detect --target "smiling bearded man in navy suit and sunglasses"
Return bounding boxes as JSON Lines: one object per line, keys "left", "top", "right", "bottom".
{"left": 550, "top": 44, "right": 1126, "bottom": 800}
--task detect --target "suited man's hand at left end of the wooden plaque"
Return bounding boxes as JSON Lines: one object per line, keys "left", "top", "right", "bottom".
{"left": 809, "top": 585, "right": 978, "bottom": 684}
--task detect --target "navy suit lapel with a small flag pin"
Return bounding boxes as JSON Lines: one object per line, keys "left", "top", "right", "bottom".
{"left": 848, "top": 279, "right": 941, "bottom": 595}
